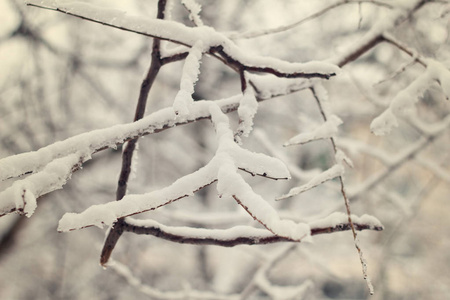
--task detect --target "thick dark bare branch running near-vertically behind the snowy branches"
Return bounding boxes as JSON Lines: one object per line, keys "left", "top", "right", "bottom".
{"left": 100, "top": 0, "right": 167, "bottom": 265}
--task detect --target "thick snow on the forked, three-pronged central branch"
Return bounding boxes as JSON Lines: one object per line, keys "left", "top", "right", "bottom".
{"left": 58, "top": 102, "right": 302, "bottom": 240}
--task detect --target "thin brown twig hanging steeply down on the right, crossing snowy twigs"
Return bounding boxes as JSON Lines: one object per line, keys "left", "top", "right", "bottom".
{"left": 310, "top": 87, "right": 374, "bottom": 295}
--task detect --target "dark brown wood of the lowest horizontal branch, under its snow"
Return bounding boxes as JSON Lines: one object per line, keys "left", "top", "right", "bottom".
{"left": 123, "top": 221, "right": 383, "bottom": 247}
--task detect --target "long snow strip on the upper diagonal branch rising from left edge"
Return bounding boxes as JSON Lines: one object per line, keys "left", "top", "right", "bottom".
{"left": 0, "top": 95, "right": 241, "bottom": 181}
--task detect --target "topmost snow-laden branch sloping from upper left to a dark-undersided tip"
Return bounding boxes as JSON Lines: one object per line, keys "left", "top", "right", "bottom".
{"left": 27, "top": 0, "right": 339, "bottom": 79}
